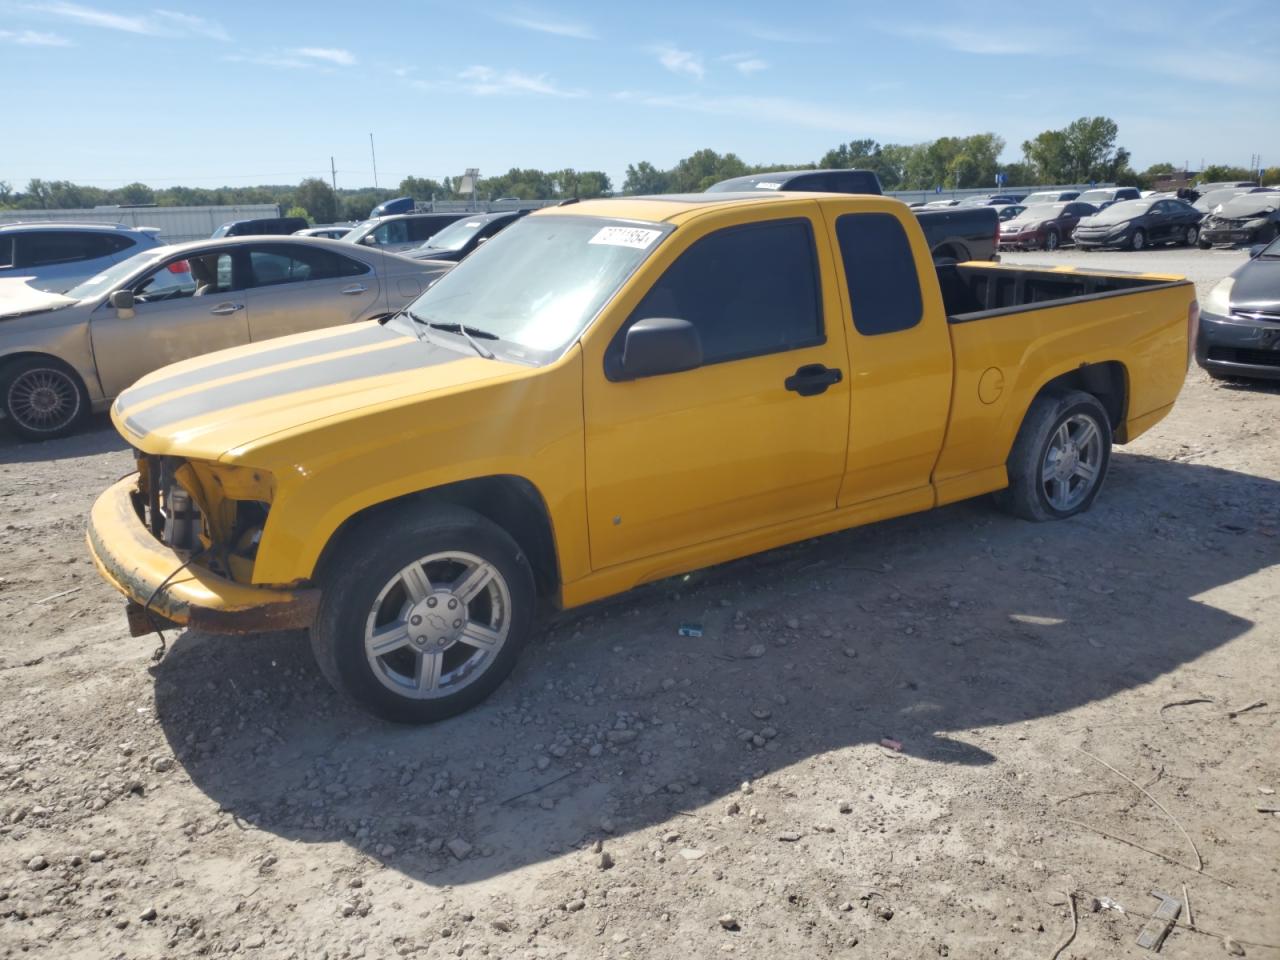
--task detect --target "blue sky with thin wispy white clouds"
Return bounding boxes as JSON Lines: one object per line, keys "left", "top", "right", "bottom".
{"left": 0, "top": 0, "right": 1280, "bottom": 188}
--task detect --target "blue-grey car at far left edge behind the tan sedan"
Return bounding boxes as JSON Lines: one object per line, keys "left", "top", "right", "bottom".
{"left": 0, "top": 221, "right": 160, "bottom": 293}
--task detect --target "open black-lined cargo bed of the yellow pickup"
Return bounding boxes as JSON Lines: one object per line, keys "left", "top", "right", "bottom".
{"left": 937, "top": 264, "right": 1187, "bottom": 324}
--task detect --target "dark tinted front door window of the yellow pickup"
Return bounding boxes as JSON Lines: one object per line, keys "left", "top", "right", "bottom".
{"left": 623, "top": 220, "right": 823, "bottom": 364}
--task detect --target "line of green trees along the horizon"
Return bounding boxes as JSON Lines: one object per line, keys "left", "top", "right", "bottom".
{"left": 0, "top": 116, "right": 1280, "bottom": 223}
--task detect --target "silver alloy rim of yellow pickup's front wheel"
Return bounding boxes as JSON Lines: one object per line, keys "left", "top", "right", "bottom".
{"left": 365, "top": 552, "right": 512, "bottom": 700}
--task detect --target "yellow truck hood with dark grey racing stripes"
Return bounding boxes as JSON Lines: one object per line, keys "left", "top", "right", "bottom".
{"left": 111, "top": 320, "right": 529, "bottom": 460}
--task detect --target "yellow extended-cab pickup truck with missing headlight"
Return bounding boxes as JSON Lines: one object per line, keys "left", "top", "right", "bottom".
{"left": 88, "top": 192, "right": 1198, "bottom": 722}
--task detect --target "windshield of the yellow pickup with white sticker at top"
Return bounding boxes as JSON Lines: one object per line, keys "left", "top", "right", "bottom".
{"left": 408, "top": 216, "right": 672, "bottom": 362}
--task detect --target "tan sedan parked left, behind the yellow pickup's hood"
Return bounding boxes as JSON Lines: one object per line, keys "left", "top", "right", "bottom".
{"left": 0, "top": 237, "right": 449, "bottom": 439}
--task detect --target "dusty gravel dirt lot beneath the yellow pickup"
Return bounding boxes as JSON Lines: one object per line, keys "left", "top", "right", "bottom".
{"left": 0, "top": 244, "right": 1280, "bottom": 960}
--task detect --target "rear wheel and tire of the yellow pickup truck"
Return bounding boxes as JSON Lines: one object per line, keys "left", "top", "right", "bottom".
{"left": 997, "top": 390, "right": 1111, "bottom": 522}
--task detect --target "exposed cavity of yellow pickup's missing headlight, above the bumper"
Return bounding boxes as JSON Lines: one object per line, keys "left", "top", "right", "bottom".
{"left": 133, "top": 454, "right": 275, "bottom": 584}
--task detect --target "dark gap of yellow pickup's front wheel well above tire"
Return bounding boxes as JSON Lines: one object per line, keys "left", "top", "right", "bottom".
{"left": 316, "top": 475, "right": 561, "bottom": 596}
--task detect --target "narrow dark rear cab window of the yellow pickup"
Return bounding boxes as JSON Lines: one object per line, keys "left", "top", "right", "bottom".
{"left": 836, "top": 214, "right": 924, "bottom": 337}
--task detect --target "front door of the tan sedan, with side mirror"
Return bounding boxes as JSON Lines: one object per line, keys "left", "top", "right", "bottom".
{"left": 90, "top": 247, "right": 250, "bottom": 397}
